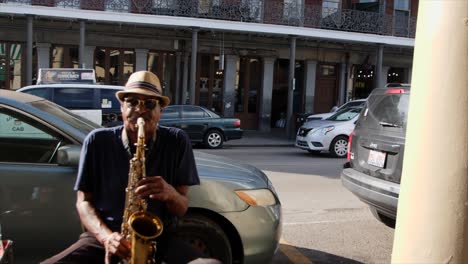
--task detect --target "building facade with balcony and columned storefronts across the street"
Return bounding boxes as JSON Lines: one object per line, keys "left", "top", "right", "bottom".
{"left": 0, "top": 0, "right": 418, "bottom": 131}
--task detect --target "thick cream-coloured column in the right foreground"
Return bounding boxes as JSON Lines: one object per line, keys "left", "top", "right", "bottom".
{"left": 392, "top": 1, "right": 468, "bottom": 263}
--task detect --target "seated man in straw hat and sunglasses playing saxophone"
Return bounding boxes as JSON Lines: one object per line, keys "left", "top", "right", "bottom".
{"left": 43, "top": 71, "right": 202, "bottom": 264}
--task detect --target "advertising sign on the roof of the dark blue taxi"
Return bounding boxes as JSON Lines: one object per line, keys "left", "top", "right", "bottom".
{"left": 36, "top": 68, "right": 96, "bottom": 84}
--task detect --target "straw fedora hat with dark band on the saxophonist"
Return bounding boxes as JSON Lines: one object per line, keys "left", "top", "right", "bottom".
{"left": 115, "top": 71, "right": 171, "bottom": 107}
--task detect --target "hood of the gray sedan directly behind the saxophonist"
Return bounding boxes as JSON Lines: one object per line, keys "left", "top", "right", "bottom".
{"left": 194, "top": 151, "right": 268, "bottom": 189}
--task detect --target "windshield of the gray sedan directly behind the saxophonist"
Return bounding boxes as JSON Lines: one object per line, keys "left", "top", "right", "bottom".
{"left": 31, "top": 100, "right": 101, "bottom": 134}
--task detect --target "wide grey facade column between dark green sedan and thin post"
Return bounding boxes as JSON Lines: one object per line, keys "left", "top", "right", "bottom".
{"left": 259, "top": 58, "right": 275, "bottom": 132}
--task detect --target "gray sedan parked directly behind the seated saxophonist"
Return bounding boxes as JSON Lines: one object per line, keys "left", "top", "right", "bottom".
{"left": 0, "top": 90, "right": 281, "bottom": 263}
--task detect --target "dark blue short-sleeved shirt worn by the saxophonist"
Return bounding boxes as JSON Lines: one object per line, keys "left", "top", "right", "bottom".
{"left": 75, "top": 126, "right": 200, "bottom": 231}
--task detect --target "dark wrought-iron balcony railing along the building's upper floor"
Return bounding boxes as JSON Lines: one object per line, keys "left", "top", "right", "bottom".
{"left": 0, "top": 0, "right": 416, "bottom": 38}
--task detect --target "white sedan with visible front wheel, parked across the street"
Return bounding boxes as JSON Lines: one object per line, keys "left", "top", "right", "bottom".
{"left": 296, "top": 107, "right": 362, "bottom": 158}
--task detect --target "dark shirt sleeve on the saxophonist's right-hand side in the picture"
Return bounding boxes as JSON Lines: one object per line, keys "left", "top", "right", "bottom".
{"left": 174, "top": 130, "right": 200, "bottom": 186}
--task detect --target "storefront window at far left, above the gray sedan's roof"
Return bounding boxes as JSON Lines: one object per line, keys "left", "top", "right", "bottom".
{"left": 0, "top": 42, "right": 24, "bottom": 90}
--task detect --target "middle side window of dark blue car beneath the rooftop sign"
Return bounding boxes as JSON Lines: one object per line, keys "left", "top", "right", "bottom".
{"left": 53, "top": 88, "right": 94, "bottom": 109}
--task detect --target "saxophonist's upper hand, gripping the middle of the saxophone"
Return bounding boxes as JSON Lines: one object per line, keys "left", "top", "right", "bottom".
{"left": 135, "top": 176, "right": 178, "bottom": 202}
